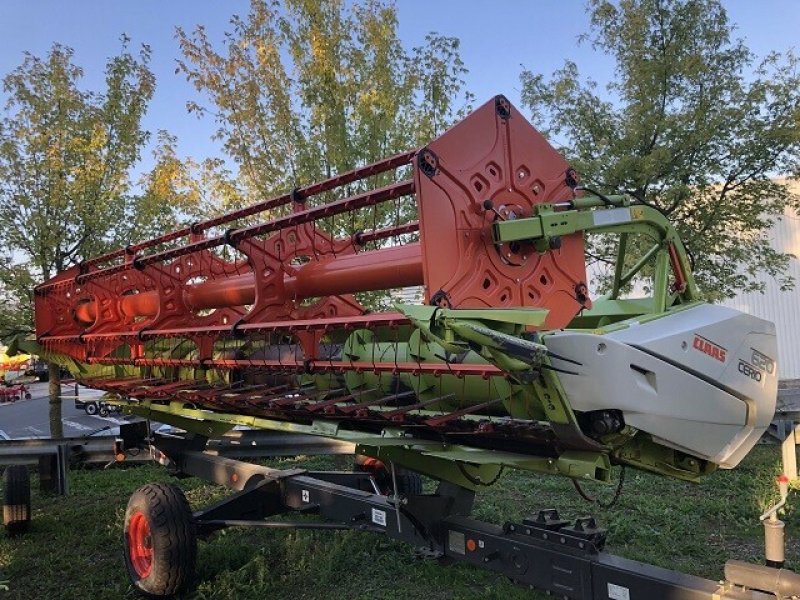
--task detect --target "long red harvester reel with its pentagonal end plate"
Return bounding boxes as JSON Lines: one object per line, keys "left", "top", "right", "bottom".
{"left": 35, "top": 97, "right": 588, "bottom": 370}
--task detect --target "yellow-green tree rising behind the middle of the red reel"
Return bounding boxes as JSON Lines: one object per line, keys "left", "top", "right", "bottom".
{"left": 177, "top": 0, "right": 471, "bottom": 214}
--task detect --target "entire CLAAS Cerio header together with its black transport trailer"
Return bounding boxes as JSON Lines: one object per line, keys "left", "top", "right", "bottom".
{"left": 14, "top": 96, "right": 800, "bottom": 599}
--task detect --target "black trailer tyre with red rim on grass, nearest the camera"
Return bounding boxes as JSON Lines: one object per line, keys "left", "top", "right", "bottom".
{"left": 124, "top": 483, "right": 197, "bottom": 598}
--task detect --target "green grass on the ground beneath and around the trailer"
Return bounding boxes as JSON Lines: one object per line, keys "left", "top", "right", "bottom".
{"left": 0, "top": 446, "right": 800, "bottom": 600}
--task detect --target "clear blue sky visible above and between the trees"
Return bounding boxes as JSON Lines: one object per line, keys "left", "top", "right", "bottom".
{"left": 0, "top": 0, "right": 800, "bottom": 171}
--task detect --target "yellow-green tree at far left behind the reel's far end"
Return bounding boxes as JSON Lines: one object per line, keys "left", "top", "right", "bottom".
{"left": 0, "top": 38, "right": 165, "bottom": 437}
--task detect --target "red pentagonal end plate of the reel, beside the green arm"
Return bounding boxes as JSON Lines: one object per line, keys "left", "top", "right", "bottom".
{"left": 415, "top": 97, "right": 586, "bottom": 328}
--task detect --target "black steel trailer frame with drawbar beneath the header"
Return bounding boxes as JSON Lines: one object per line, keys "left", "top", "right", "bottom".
{"left": 136, "top": 434, "right": 800, "bottom": 600}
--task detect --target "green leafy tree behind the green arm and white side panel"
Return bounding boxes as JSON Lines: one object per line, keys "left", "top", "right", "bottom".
{"left": 522, "top": 0, "right": 800, "bottom": 299}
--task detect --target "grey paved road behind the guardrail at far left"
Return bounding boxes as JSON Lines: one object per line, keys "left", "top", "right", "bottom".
{"left": 0, "top": 383, "right": 130, "bottom": 440}
